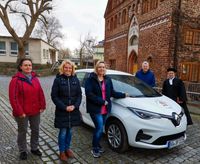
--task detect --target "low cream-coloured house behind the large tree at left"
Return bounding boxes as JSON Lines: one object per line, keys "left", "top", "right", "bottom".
{"left": 0, "top": 36, "right": 58, "bottom": 64}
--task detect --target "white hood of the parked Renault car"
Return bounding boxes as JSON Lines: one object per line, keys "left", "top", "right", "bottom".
{"left": 114, "top": 95, "right": 181, "bottom": 115}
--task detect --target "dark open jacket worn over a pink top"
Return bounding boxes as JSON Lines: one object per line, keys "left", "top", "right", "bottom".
{"left": 85, "top": 72, "right": 126, "bottom": 114}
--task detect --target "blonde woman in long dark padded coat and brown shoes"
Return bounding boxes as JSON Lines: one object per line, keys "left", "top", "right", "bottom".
{"left": 51, "top": 60, "right": 82, "bottom": 161}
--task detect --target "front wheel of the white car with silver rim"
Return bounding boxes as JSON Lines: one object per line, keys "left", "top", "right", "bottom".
{"left": 106, "top": 119, "right": 129, "bottom": 153}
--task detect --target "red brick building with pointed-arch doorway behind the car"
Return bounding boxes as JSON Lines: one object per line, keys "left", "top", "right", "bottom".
{"left": 104, "top": 0, "right": 200, "bottom": 83}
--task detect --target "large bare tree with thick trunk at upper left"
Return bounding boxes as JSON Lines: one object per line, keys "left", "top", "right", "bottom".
{"left": 0, "top": 0, "right": 52, "bottom": 62}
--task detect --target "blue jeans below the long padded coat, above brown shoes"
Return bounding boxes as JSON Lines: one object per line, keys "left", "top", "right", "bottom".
{"left": 58, "top": 128, "right": 72, "bottom": 152}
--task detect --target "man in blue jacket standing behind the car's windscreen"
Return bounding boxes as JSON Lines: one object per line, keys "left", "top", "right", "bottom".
{"left": 135, "top": 61, "right": 155, "bottom": 87}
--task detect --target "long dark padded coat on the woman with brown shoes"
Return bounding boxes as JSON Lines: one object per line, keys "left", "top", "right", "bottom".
{"left": 51, "top": 74, "right": 82, "bottom": 128}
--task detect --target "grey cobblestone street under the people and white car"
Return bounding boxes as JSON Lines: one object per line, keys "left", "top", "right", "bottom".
{"left": 0, "top": 76, "right": 200, "bottom": 164}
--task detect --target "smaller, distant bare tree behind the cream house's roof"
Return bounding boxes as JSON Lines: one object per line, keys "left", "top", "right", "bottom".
{"left": 34, "top": 16, "right": 63, "bottom": 48}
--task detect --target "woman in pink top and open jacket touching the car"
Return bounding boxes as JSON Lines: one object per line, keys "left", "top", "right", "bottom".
{"left": 85, "top": 61, "right": 126, "bottom": 158}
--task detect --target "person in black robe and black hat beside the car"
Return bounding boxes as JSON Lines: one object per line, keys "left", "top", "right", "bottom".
{"left": 162, "top": 68, "right": 193, "bottom": 125}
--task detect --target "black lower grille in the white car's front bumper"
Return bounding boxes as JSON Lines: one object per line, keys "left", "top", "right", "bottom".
{"left": 152, "top": 131, "right": 185, "bottom": 145}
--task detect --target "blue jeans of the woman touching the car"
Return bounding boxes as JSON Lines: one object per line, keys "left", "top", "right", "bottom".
{"left": 90, "top": 114, "right": 107, "bottom": 150}
